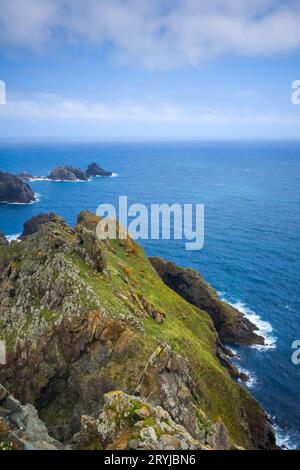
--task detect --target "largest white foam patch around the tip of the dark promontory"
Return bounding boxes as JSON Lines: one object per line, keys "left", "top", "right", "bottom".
{"left": 228, "top": 301, "right": 276, "bottom": 351}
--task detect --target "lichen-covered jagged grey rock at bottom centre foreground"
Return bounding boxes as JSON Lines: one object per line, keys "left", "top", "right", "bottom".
{"left": 74, "top": 391, "right": 209, "bottom": 450}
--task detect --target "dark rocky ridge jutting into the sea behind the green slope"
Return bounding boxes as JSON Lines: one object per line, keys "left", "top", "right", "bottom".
{"left": 149, "top": 257, "right": 264, "bottom": 345}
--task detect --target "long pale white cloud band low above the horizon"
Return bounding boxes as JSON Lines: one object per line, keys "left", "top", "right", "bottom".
{"left": 0, "top": 93, "right": 299, "bottom": 124}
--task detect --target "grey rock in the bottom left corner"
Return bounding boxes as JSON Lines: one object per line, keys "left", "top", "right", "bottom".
{"left": 0, "top": 384, "right": 63, "bottom": 450}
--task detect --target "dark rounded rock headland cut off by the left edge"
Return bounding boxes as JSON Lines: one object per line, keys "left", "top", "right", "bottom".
{"left": 0, "top": 172, "right": 36, "bottom": 204}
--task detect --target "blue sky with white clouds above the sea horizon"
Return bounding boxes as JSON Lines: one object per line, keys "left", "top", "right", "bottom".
{"left": 0, "top": 0, "right": 300, "bottom": 140}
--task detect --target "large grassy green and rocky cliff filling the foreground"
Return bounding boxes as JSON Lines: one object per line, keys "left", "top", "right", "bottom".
{"left": 0, "top": 212, "right": 275, "bottom": 449}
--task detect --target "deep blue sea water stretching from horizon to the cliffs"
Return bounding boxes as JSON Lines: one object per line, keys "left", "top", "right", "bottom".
{"left": 0, "top": 142, "right": 300, "bottom": 448}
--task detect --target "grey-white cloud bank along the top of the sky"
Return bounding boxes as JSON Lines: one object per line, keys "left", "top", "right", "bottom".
{"left": 0, "top": 0, "right": 300, "bottom": 68}
